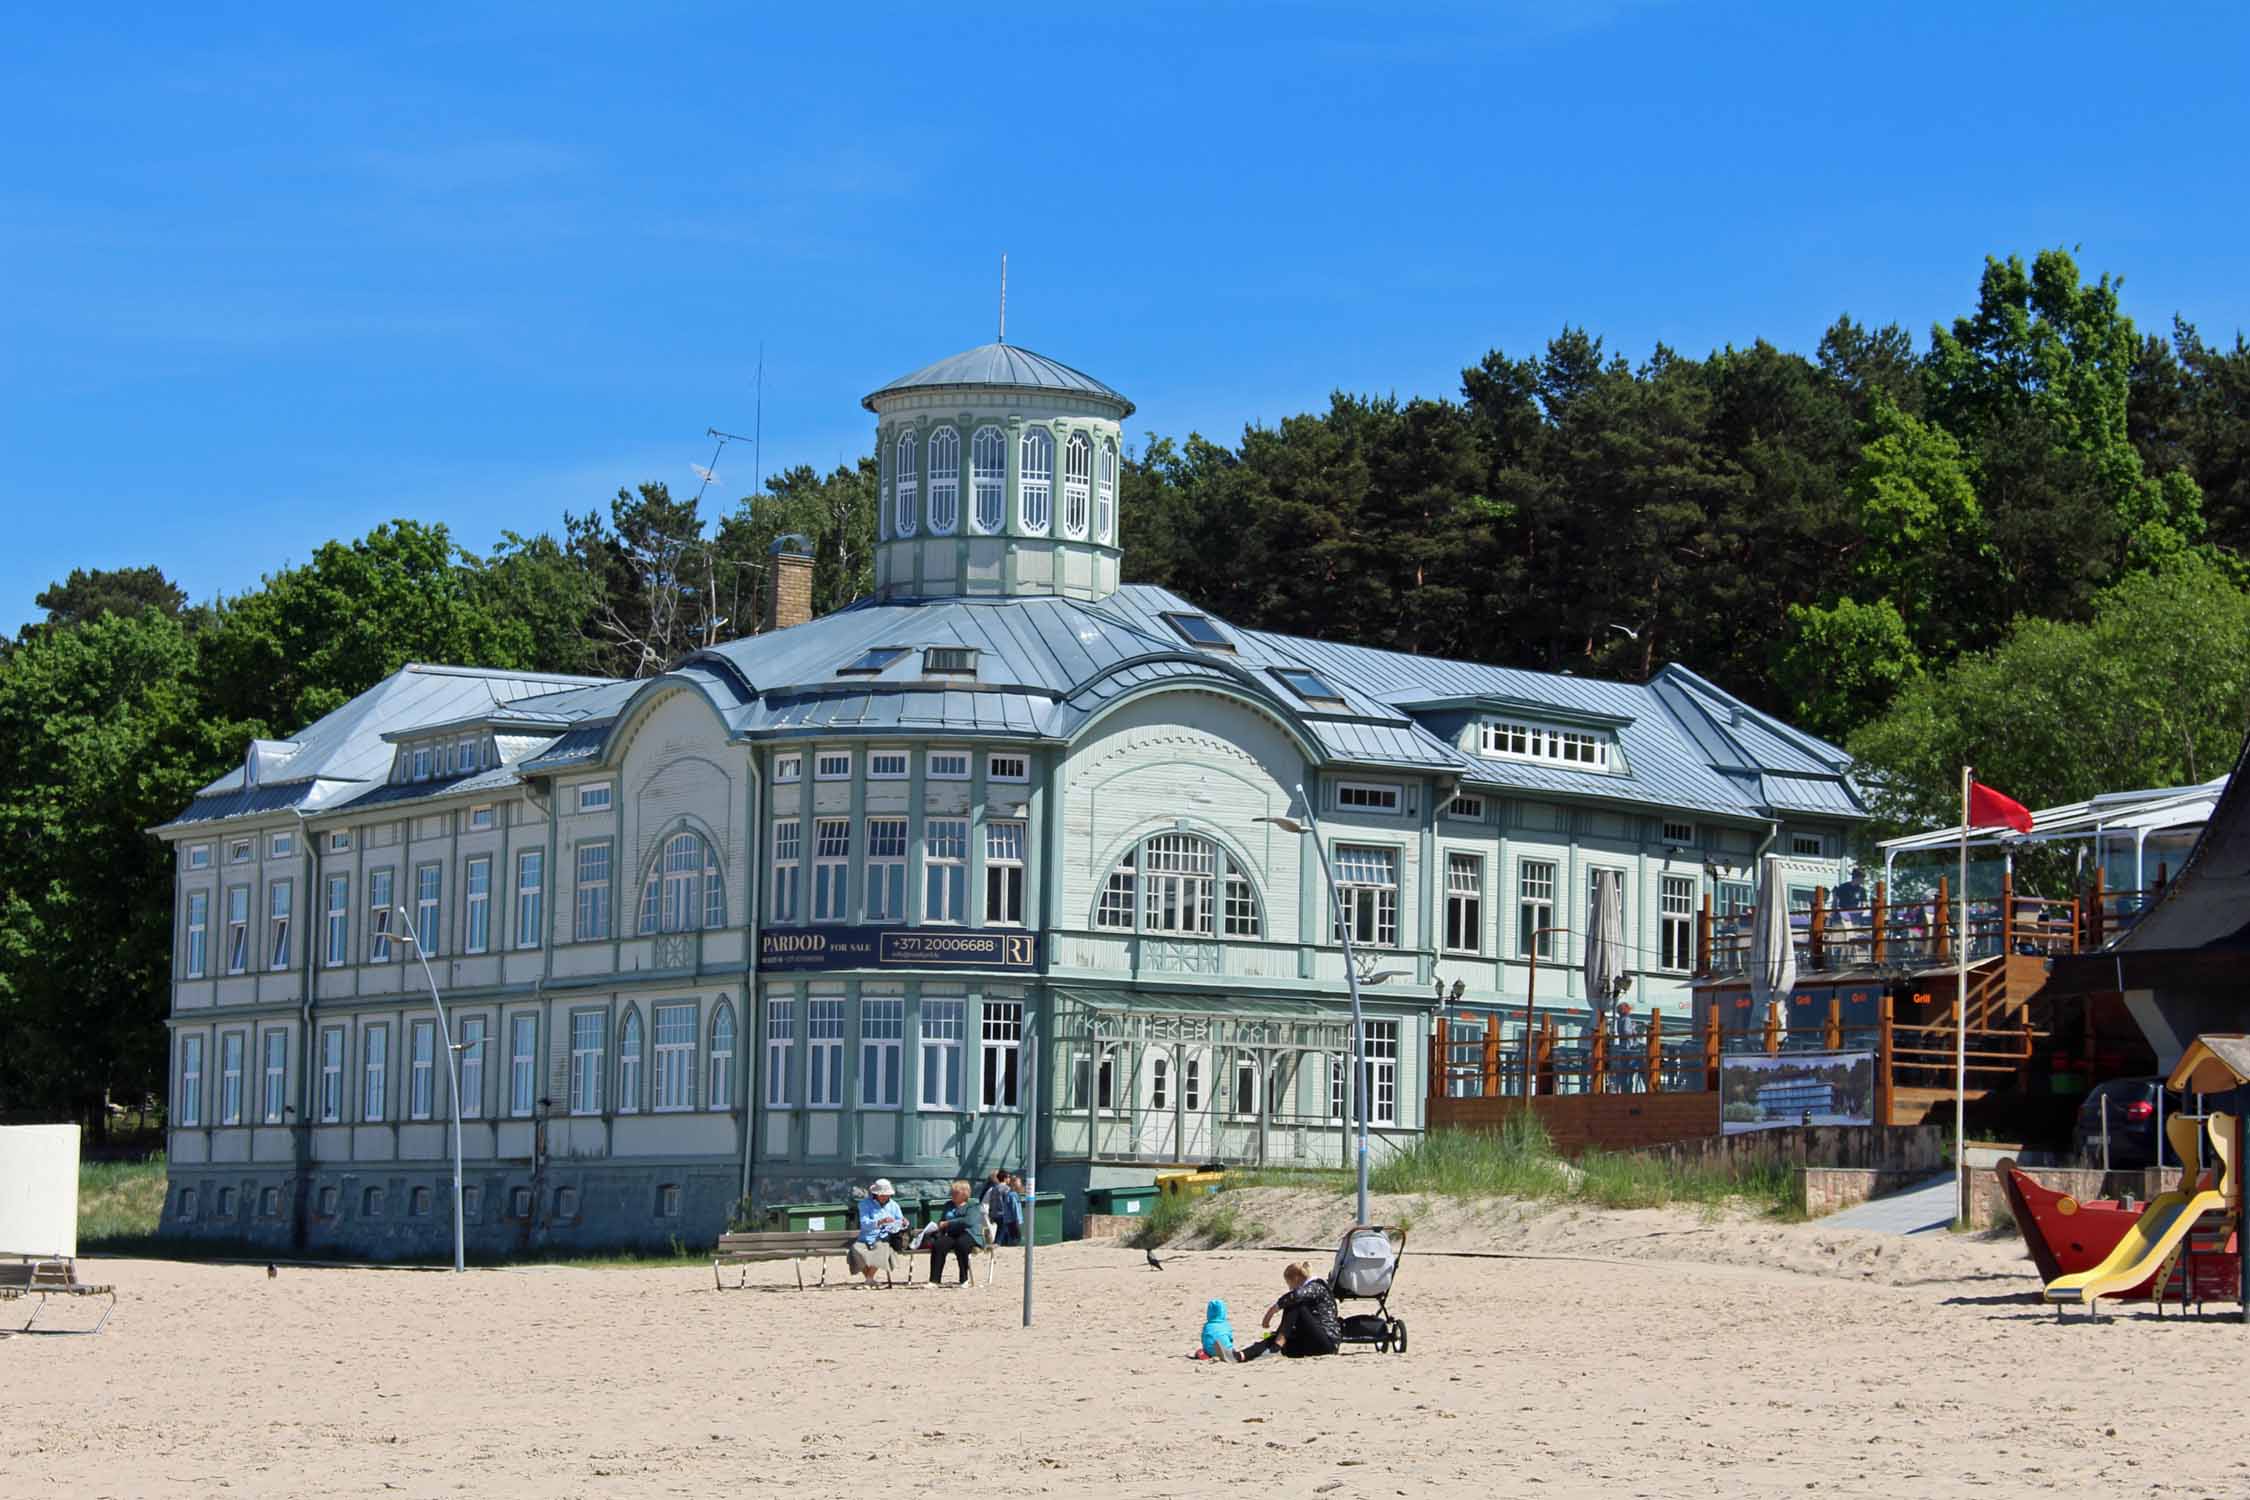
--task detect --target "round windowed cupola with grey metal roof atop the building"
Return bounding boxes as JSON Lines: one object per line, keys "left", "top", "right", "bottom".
{"left": 860, "top": 342, "right": 1134, "bottom": 598}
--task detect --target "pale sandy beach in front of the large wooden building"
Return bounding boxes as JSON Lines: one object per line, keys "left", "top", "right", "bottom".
{"left": 0, "top": 1192, "right": 2250, "bottom": 1500}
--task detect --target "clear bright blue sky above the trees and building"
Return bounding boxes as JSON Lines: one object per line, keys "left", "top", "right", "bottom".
{"left": 0, "top": 0, "right": 2250, "bottom": 630}
